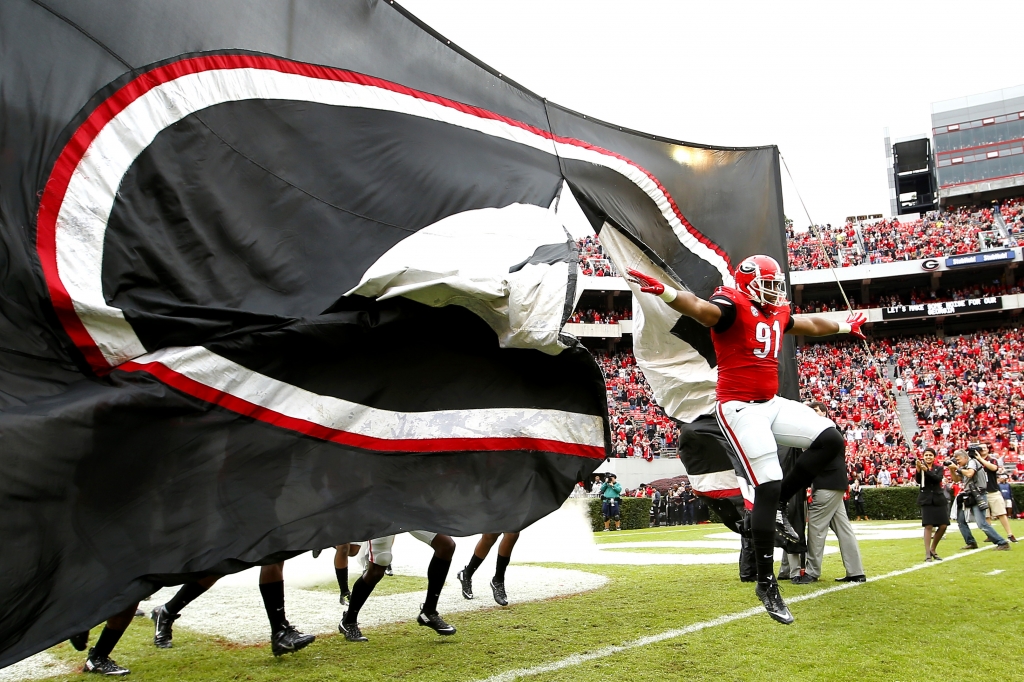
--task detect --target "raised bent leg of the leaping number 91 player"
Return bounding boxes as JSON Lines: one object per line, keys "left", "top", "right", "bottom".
{"left": 770, "top": 396, "right": 846, "bottom": 502}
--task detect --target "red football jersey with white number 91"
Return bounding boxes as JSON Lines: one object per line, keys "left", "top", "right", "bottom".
{"left": 710, "top": 287, "right": 793, "bottom": 402}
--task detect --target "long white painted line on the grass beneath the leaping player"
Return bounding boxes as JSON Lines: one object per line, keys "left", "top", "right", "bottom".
{"left": 483, "top": 547, "right": 993, "bottom": 682}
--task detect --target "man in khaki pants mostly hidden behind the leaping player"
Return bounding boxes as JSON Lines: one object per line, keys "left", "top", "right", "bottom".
{"left": 779, "top": 402, "right": 866, "bottom": 585}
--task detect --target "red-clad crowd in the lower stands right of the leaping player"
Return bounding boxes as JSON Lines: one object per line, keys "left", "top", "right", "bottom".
{"left": 797, "top": 329, "right": 1024, "bottom": 485}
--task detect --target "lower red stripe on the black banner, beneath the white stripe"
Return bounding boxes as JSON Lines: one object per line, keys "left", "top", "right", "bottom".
{"left": 118, "top": 361, "right": 604, "bottom": 460}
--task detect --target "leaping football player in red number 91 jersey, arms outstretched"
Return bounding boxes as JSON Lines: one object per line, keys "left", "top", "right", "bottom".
{"left": 629, "top": 256, "right": 866, "bottom": 625}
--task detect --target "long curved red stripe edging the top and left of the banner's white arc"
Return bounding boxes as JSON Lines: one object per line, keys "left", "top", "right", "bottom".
{"left": 36, "top": 54, "right": 731, "bottom": 372}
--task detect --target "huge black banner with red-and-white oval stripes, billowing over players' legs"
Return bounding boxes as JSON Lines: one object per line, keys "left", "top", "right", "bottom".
{"left": 0, "top": 0, "right": 782, "bottom": 666}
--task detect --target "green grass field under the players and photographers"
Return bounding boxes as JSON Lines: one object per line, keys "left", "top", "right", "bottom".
{"left": 18, "top": 521, "right": 1024, "bottom": 682}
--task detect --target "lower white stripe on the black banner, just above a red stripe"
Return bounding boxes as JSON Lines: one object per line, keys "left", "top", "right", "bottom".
{"left": 133, "top": 347, "right": 604, "bottom": 446}
